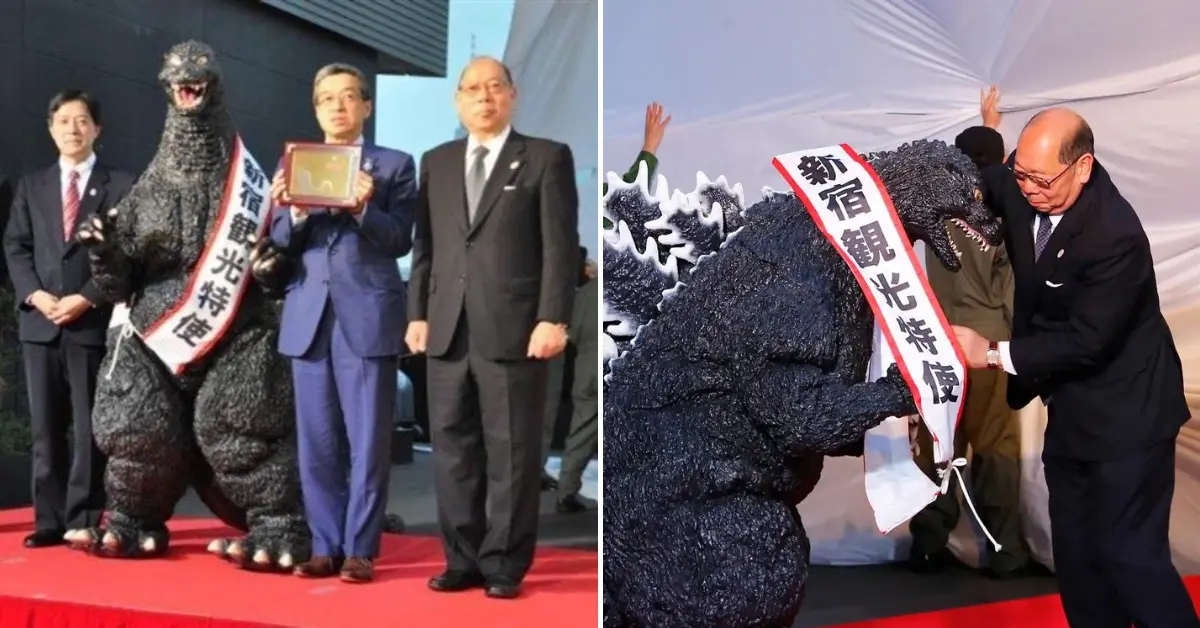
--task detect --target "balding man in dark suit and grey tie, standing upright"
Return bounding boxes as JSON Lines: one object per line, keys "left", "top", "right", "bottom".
{"left": 406, "top": 58, "right": 578, "bottom": 598}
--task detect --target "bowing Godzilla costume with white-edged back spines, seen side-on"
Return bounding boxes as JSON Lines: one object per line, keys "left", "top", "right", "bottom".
{"left": 604, "top": 140, "right": 1001, "bottom": 628}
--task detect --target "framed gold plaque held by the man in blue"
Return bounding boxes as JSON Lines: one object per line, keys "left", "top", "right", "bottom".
{"left": 283, "top": 142, "right": 362, "bottom": 209}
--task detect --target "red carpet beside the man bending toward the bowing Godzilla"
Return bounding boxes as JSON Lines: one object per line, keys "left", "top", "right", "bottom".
{"left": 836, "top": 576, "right": 1200, "bottom": 628}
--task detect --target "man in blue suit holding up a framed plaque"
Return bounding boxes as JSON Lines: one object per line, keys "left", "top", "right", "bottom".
{"left": 271, "top": 64, "right": 416, "bottom": 582}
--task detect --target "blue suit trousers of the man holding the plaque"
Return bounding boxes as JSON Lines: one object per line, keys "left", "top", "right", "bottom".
{"left": 292, "top": 304, "right": 397, "bottom": 558}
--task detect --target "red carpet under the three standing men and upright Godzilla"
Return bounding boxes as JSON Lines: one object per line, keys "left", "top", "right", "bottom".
{"left": 0, "top": 509, "right": 599, "bottom": 628}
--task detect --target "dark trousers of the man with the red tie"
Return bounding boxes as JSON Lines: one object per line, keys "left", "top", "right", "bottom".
{"left": 22, "top": 340, "right": 104, "bottom": 532}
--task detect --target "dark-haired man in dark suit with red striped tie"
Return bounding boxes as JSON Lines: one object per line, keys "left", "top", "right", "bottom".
{"left": 4, "top": 90, "right": 133, "bottom": 548}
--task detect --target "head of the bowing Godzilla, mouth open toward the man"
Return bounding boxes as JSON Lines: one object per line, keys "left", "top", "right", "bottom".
{"left": 868, "top": 139, "right": 1002, "bottom": 271}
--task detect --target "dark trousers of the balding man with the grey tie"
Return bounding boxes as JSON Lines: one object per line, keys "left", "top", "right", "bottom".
{"left": 427, "top": 315, "right": 546, "bottom": 580}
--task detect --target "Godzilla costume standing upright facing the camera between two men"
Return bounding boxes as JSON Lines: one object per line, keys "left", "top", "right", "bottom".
{"left": 68, "top": 42, "right": 310, "bottom": 569}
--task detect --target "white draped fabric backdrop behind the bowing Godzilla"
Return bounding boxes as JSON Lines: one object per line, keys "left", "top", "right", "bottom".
{"left": 604, "top": 0, "right": 1200, "bottom": 573}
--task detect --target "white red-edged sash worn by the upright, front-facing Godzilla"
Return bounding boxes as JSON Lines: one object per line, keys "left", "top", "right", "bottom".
{"left": 138, "top": 136, "right": 270, "bottom": 375}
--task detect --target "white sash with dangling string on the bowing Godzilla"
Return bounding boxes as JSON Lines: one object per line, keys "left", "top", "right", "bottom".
{"left": 773, "top": 144, "right": 998, "bottom": 548}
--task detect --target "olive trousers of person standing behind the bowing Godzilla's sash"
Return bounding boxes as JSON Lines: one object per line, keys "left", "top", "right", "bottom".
{"left": 908, "top": 369, "right": 1030, "bottom": 572}
